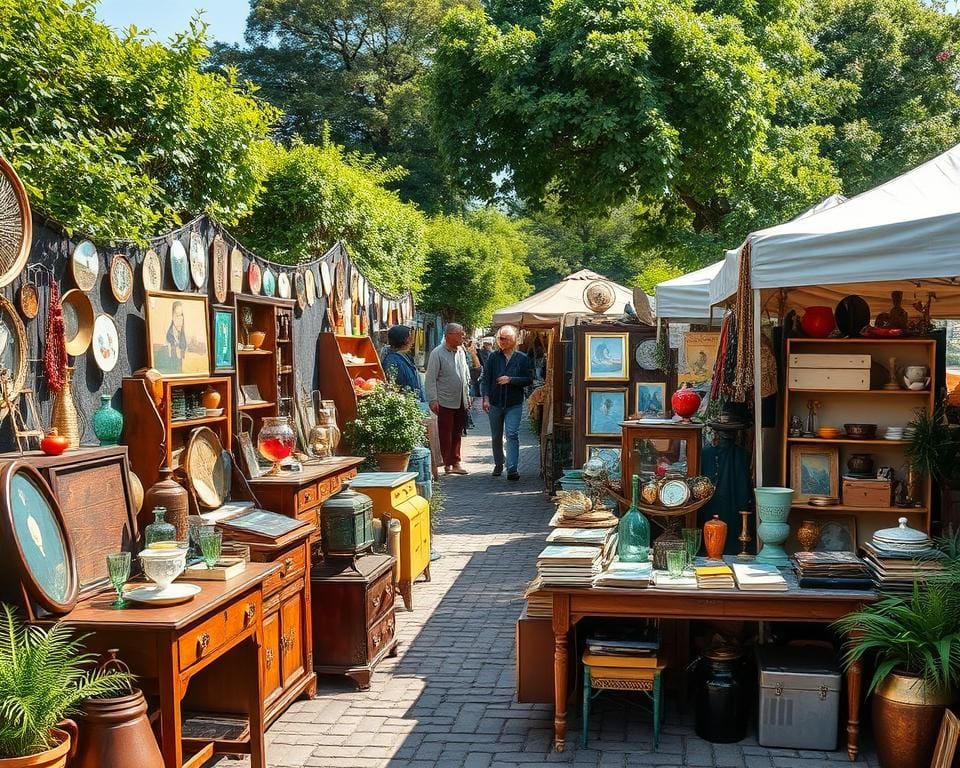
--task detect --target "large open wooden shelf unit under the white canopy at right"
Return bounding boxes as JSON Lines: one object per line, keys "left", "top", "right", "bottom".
{"left": 780, "top": 338, "right": 937, "bottom": 546}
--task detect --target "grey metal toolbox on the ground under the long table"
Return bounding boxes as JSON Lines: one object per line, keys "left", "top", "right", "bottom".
{"left": 757, "top": 645, "right": 840, "bottom": 751}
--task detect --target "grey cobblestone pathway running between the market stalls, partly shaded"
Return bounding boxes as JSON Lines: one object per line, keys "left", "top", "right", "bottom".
{"left": 216, "top": 414, "right": 876, "bottom": 768}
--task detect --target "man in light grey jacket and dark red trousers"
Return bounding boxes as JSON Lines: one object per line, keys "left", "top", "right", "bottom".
{"left": 424, "top": 323, "right": 470, "bottom": 475}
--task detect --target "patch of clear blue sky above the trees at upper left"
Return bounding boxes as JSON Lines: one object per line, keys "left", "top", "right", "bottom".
{"left": 97, "top": 0, "right": 250, "bottom": 43}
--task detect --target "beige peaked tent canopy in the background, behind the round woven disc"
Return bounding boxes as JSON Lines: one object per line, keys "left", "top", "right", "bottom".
{"left": 493, "top": 269, "right": 653, "bottom": 328}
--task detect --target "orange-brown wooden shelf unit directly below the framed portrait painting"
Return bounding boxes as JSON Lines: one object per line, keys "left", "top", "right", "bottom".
{"left": 122, "top": 376, "right": 233, "bottom": 489}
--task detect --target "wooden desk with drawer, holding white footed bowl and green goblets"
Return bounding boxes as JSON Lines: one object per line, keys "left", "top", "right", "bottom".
{"left": 63, "top": 563, "right": 281, "bottom": 768}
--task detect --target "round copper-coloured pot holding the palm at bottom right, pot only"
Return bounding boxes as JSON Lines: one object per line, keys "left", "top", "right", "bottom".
{"left": 873, "top": 672, "right": 953, "bottom": 768}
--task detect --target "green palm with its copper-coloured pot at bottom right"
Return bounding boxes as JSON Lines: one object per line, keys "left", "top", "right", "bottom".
{"left": 836, "top": 581, "right": 960, "bottom": 768}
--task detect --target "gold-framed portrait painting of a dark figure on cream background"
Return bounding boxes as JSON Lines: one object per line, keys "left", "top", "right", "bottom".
{"left": 145, "top": 291, "right": 210, "bottom": 377}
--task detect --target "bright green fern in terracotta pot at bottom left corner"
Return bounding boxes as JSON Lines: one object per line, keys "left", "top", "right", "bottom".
{"left": 0, "top": 604, "right": 131, "bottom": 768}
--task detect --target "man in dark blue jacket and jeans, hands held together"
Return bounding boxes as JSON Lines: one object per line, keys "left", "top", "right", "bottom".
{"left": 480, "top": 325, "right": 533, "bottom": 480}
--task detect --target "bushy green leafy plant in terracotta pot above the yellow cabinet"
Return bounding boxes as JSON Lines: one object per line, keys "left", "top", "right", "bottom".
{"left": 344, "top": 381, "right": 427, "bottom": 472}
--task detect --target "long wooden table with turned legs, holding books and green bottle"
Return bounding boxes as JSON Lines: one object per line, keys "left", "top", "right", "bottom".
{"left": 544, "top": 578, "right": 876, "bottom": 761}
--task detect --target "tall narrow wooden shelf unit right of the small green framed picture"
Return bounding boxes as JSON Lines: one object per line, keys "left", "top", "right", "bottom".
{"left": 233, "top": 294, "right": 296, "bottom": 439}
